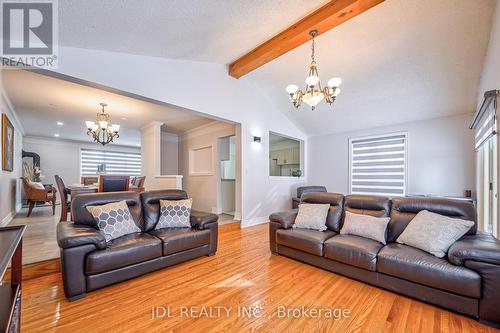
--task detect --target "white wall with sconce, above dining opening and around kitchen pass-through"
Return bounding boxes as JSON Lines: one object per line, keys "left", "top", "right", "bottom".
{"left": 51, "top": 46, "right": 307, "bottom": 226}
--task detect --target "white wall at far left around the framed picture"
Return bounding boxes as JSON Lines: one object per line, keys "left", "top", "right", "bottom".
{"left": 0, "top": 84, "right": 24, "bottom": 226}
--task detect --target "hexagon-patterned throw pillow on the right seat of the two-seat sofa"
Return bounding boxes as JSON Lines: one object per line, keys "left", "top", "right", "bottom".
{"left": 155, "top": 198, "right": 193, "bottom": 229}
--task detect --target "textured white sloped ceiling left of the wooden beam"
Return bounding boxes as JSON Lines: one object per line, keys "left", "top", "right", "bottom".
{"left": 59, "top": 0, "right": 328, "bottom": 64}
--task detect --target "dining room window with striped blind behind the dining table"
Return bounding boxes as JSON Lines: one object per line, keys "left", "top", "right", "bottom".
{"left": 80, "top": 149, "right": 141, "bottom": 176}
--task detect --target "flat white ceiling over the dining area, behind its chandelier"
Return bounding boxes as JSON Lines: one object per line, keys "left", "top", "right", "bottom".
{"left": 2, "top": 69, "right": 214, "bottom": 146}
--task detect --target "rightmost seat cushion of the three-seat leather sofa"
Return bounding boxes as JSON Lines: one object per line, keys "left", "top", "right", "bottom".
{"left": 377, "top": 243, "right": 481, "bottom": 298}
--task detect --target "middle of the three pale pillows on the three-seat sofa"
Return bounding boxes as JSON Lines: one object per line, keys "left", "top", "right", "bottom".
{"left": 340, "top": 211, "right": 391, "bottom": 244}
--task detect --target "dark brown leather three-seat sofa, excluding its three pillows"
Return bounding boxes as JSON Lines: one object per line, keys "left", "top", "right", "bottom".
{"left": 269, "top": 193, "right": 500, "bottom": 327}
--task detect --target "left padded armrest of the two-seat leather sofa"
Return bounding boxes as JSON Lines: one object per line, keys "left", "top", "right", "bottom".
{"left": 57, "top": 222, "right": 106, "bottom": 249}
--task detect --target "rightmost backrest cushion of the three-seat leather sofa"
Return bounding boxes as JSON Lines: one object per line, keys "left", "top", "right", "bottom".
{"left": 387, "top": 197, "right": 477, "bottom": 243}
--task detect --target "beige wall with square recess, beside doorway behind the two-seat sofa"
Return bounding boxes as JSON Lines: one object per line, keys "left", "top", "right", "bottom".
{"left": 179, "top": 122, "right": 238, "bottom": 212}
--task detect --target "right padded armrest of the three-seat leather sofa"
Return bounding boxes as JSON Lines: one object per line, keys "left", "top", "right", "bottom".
{"left": 448, "top": 232, "right": 500, "bottom": 266}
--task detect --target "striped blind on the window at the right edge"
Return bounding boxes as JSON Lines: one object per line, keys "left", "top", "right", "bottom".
{"left": 470, "top": 90, "right": 498, "bottom": 150}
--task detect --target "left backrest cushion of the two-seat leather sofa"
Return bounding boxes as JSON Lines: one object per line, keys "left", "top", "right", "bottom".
{"left": 71, "top": 191, "right": 144, "bottom": 229}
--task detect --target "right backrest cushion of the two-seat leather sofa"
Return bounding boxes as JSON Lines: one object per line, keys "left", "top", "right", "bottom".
{"left": 141, "top": 190, "right": 188, "bottom": 232}
